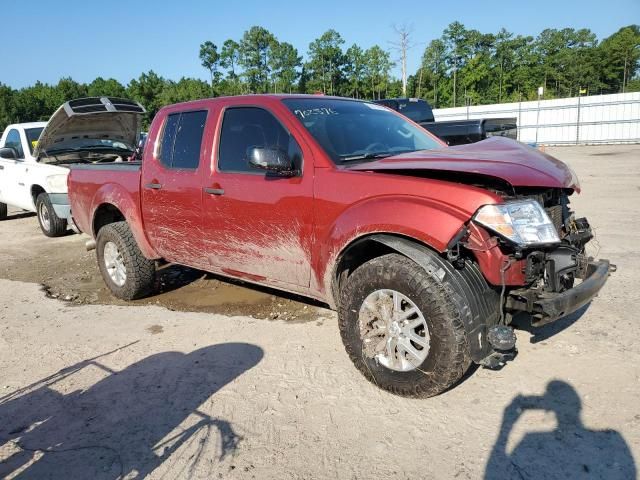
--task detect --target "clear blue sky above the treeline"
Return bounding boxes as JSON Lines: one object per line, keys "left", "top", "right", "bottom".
{"left": 0, "top": 0, "right": 640, "bottom": 88}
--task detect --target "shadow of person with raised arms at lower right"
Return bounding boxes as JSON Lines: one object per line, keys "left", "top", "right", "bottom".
{"left": 484, "top": 380, "right": 636, "bottom": 480}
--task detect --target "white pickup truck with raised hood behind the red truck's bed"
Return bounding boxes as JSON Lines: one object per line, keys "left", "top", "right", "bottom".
{"left": 0, "top": 97, "right": 145, "bottom": 237}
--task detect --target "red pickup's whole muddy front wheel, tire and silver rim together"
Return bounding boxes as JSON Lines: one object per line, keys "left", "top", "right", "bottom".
{"left": 338, "top": 254, "right": 471, "bottom": 397}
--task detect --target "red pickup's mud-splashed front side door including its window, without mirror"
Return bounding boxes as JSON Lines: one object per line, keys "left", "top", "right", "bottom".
{"left": 203, "top": 106, "right": 313, "bottom": 287}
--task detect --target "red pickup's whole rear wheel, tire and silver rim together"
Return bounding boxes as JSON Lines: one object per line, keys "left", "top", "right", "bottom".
{"left": 96, "top": 222, "right": 156, "bottom": 300}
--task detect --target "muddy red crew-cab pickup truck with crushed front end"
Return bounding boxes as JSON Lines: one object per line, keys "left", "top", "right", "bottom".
{"left": 68, "top": 95, "right": 612, "bottom": 397}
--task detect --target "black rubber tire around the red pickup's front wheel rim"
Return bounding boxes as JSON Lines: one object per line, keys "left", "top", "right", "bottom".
{"left": 338, "top": 253, "right": 471, "bottom": 398}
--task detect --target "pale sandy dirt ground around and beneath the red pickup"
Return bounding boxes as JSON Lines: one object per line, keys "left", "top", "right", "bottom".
{"left": 0, "top": 146, "right": 640, "bottom": 479}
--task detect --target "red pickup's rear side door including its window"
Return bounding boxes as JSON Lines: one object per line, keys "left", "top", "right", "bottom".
{"left": 141, "top": 109, "right": 212, "bottom": 267}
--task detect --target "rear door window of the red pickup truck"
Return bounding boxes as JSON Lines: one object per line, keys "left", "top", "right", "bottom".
{"left": 159, "top": 110, "right": 207, "bottom": 170}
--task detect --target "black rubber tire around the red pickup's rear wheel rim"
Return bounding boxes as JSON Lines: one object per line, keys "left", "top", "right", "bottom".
{"left": 96, "top": 222, "right": 156, "bottom": 300}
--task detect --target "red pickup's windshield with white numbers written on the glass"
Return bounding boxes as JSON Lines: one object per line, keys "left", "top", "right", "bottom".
{"left": 283, "top": 97, "right": 441, "bottom": 165}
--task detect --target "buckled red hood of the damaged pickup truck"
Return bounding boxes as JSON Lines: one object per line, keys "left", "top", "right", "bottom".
{"left": 346, "top": 137, "right": 580, "bottom": 192}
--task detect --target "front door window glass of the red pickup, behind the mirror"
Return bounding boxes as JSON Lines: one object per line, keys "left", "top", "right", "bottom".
{"left": 218, "top": 107, "right": 302, "bottom": 174}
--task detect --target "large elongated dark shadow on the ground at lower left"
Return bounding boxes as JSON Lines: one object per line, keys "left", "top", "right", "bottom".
{"left": 0, "top": 343, "right": 263, "bottom": 479}
